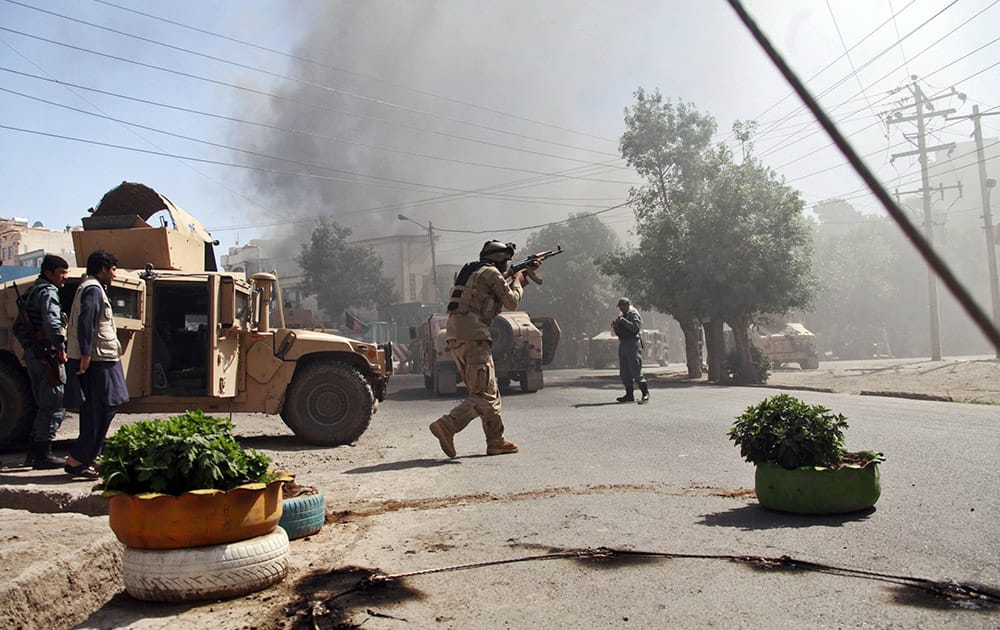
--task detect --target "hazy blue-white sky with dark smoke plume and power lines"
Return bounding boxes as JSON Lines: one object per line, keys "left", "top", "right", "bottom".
{"left": 0, "top": 0, "right": 1000, "bottom": 263}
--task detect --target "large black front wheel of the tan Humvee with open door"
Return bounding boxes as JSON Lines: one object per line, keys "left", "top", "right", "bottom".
{"left": 281, "top": 361, "right": 375, "bottom": 446}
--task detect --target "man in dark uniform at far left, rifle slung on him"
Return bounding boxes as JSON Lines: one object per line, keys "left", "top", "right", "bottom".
{"left": 18, "top": 254, "right": 69, "bottom": 470}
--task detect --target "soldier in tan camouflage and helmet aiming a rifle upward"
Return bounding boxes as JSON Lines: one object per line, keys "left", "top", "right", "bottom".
{"left": 430, "top": 241, "right": 541, "bottom": 457}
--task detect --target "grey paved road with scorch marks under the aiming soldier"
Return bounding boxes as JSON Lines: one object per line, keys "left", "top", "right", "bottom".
{"left": 79, "top": 370, "right": 1000, "bottom": 629}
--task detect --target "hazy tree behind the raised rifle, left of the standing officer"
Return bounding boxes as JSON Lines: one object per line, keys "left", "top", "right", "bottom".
{"left": 518, "top": 213, "right": 618, "bottom": 337}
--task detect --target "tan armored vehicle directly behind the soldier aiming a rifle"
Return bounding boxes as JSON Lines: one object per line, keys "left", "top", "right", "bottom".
{"left": 410, "top": 311, "right": 561, "bottom": 395}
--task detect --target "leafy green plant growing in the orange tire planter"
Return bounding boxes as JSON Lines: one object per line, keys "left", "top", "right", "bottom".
{"left": 97, "top": 411, "right": 278, "bottom": 495}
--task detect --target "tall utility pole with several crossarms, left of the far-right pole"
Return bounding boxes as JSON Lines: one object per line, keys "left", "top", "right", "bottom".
{"left": 886, "top": 76, "right": 956, "bottom": 361}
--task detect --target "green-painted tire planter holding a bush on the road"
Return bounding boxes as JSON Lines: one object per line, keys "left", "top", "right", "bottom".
{"left": 754, "top": 459, "right": 882, "bottom": 514}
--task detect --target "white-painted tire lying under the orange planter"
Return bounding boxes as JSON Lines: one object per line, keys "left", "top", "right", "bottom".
{"left": 122, "top": 527, "right": 289, "bottom": 602}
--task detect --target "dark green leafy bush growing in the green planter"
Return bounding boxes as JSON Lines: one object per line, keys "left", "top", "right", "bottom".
{"left": 729, "top": 394, "right": 847, "bottom": 468}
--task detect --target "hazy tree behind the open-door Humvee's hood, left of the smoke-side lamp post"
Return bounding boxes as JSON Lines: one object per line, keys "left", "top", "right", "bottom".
{"left": 295, "top": 218, "right": 398, "bottom": 318}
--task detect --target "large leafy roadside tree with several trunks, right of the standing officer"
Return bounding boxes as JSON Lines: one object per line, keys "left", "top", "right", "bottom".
{"left": 602, "top": 89, "right": 814, "bottom": 380}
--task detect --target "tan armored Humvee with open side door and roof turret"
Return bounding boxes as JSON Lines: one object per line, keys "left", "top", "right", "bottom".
{"left": 0, "top": 183, "right": 392, "bottom": 448}
